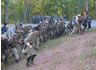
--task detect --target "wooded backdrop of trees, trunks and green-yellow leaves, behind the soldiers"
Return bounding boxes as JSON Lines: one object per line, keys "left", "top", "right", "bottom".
{"left": 1, "top": 0, "right": 96, "bottom": 23}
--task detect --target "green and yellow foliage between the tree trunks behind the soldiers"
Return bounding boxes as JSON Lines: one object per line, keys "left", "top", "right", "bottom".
{"left": 1, "top": 0, "right": 96, "bottom": 23}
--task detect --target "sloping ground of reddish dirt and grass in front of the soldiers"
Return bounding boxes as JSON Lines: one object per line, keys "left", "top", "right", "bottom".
{"left": 2, "top": 29, "right": 96, "bottom": 70}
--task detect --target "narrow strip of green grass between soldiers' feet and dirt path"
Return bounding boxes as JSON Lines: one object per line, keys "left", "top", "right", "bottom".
{"left": 40, "top": 35, "right": 70, "bottom": 51}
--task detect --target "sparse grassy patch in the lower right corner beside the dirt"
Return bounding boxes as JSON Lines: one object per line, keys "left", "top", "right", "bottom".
{"left": 76, "top": 40, "right": 96, "bottom": 70}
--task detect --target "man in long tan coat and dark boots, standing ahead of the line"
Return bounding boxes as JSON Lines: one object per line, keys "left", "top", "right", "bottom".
{"left": 22, "top": 30, "right": 39, "bottom": 66}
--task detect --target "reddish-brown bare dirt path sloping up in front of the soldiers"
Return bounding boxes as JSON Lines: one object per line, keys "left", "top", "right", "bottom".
{"left": 2, "top": 31, "right": 96, "bottom": 70}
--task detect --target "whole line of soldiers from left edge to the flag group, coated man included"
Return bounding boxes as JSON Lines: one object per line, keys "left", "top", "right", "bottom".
{"left": 1, "top": 15, "right": 91, "bottom": 66}
